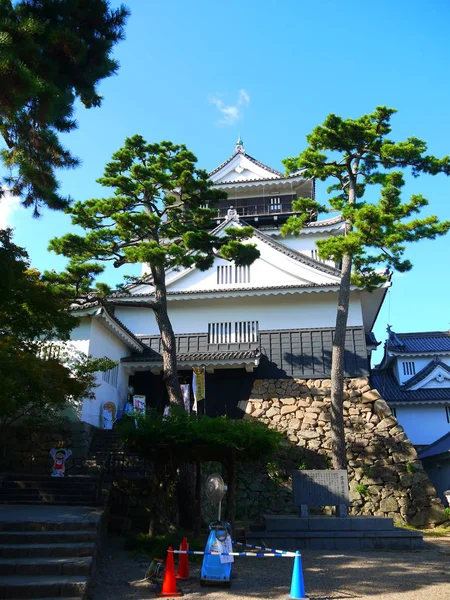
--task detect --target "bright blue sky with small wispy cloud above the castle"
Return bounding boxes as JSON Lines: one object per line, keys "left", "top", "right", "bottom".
{"left": 2, "top": 0, "right": 450, "bottom": 360}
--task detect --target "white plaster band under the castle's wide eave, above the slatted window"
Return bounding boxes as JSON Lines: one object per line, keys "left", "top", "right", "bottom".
{"left": 116, "top": 292, "right": 362, "bottom": 335}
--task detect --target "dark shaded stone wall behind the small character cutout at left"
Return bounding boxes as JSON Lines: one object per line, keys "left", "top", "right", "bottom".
{"left": 0, "top": 421, "right": 95, "bottom": 474}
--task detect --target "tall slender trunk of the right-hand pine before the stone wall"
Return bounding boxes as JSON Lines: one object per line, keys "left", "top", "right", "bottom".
{"left": 331, "top": 254, "right": 352, "bottom": 469}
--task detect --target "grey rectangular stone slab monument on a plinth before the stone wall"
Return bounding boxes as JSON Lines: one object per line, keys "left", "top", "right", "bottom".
{"left": 292, "top": 470, "right": 350, "bottom": 506}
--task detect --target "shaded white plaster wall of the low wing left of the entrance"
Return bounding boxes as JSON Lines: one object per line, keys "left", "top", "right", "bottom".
{"left": 81, "top": 319, "right": 130, "bottom": 427}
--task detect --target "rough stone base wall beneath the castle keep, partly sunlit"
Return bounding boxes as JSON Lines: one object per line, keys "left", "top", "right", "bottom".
{"left": 243, "top": 378, "right": 446, "bottom": 526}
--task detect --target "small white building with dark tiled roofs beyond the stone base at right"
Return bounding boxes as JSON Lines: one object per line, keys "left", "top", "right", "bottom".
{"left": 371, "top": 327, "right": 450, "bottom": 448}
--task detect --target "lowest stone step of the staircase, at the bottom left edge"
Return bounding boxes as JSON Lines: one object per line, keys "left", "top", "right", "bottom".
{"left": 0, "top": 575, "right": 88, "bottom": 599}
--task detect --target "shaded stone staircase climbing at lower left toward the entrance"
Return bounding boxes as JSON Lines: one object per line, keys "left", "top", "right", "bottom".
{"left": 0, "top": 430, "right": 125, "bottom": 600}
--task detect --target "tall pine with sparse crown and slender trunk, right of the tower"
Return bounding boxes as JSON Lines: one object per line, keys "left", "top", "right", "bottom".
{"left": 282, "top": 106, "right": 450, "bottom": 469}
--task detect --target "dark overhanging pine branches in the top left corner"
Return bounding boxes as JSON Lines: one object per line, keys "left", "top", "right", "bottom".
{"left": 0, "top": 0, "right": 128, "bottom": 216}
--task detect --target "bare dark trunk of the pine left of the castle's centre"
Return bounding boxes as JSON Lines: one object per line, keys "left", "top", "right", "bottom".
{"left": 152, "top": 266, "right": 183, "bottom": 406}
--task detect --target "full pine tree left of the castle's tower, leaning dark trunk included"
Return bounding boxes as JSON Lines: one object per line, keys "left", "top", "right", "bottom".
{"left": 50, "top": 135, "right": 259, "bottom": 405}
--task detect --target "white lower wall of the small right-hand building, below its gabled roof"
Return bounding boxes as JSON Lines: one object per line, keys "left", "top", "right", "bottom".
{"left": 396, "top": 406, "right": 450, "bottom": 445}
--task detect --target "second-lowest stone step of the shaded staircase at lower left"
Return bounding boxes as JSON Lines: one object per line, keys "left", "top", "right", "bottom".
{"left": 0, "top": 556, "right": 93, "bottom": 576}
